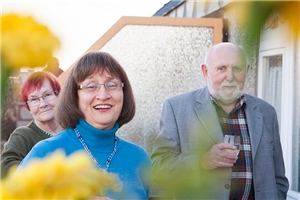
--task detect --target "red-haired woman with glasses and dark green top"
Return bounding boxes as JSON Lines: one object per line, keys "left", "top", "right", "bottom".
{"left": 1, "top": 71, "right": 62, "bottom": 178}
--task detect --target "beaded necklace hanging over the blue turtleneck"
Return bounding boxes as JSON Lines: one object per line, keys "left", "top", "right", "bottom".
{"left": 74, "top": 127, "right": 117, "bottom": 170}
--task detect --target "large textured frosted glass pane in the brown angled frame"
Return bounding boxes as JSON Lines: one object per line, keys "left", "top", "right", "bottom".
{"left": 100, "top": 25, "right": 214, "bottom": 153}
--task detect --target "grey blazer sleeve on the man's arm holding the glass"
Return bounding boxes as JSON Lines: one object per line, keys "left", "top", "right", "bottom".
{"left": 151, "top": 100, "right": 200, "bottom": 188}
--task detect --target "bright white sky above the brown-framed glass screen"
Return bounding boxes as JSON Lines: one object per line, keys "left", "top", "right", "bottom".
{"left": 1, "top": 0, "right": 170, "bottom": 71}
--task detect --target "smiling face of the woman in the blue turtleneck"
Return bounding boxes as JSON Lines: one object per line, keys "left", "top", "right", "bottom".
{"left": 78, "top": 71, "right": 124, "bottom": 130}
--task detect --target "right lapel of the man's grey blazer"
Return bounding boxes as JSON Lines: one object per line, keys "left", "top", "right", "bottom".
{"left": 246, "top": 96, "right": 263, "bottom": 161}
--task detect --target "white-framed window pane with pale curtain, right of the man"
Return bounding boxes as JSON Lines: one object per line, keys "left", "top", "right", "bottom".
{"left": 263, "top": 55, "right": 282, "bottom": 124}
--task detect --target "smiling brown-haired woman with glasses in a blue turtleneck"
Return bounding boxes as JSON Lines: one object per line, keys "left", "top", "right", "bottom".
{"left": 21, "top": 51, "right": 151, "bottom": 199}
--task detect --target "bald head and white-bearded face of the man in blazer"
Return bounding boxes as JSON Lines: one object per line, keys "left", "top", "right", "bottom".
{"left": 202, "top": 43, "right": 247, "bottom": 105}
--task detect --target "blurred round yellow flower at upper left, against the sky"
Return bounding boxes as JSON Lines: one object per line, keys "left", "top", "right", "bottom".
{"left": 0, "top": 14, "right": 60, "bottom": 69}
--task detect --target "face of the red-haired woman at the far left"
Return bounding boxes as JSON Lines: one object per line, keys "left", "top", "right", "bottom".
{"left": 28, "top": 79, "right": 57, "bottom": 123}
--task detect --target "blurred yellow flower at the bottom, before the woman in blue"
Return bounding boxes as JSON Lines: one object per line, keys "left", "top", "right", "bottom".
{"left": 1, "top": 150, "right": 121, "bottom": 199}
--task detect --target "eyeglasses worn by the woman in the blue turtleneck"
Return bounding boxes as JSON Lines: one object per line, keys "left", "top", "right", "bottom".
{"left": 77, "top": 81, "right": 124, "bottom": 92}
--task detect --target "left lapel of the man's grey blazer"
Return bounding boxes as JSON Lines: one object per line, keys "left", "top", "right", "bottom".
{"left": 194, "top": 87, "right": 223, "bottom": 143}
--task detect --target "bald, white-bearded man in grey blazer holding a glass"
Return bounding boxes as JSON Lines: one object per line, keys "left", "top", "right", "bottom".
{"left": 151, "top": 43, "right": 289, "bottom": 200}
